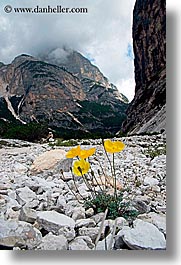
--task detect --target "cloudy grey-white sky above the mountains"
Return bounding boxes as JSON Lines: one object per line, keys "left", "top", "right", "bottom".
{"left": 0, "top": 0, "right": 135, "bottom": 100}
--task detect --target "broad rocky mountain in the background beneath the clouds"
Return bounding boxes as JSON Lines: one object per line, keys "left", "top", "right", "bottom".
{"left": 0, "top": 52, "right": 128, "bottom": 137}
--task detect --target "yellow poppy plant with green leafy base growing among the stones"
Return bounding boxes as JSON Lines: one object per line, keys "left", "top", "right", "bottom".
{"left": 61, "top": 140, "right": 138, "bottom": 221}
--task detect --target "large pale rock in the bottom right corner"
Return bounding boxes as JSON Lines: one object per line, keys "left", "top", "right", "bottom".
{"left": 122, "top": 219, "right": 166, "bottom": 250}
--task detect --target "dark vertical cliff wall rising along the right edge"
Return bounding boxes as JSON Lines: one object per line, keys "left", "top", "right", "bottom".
{"left": 122, "top": 0, "right": 166, "bottom": 133}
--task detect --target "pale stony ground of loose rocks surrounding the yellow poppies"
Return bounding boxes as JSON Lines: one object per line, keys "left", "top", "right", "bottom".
{"left": 0, "top": 135, "right": 166, "bottom": 250}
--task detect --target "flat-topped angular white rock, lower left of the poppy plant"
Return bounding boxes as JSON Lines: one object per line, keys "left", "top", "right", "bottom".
{"left": 37, "top": 211, "right": 75, "bottom": 233}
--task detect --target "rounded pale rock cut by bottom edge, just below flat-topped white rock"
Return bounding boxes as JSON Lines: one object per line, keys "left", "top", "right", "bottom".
{"left": 37, "top": 233, "right": 68, "bottom": 250}
